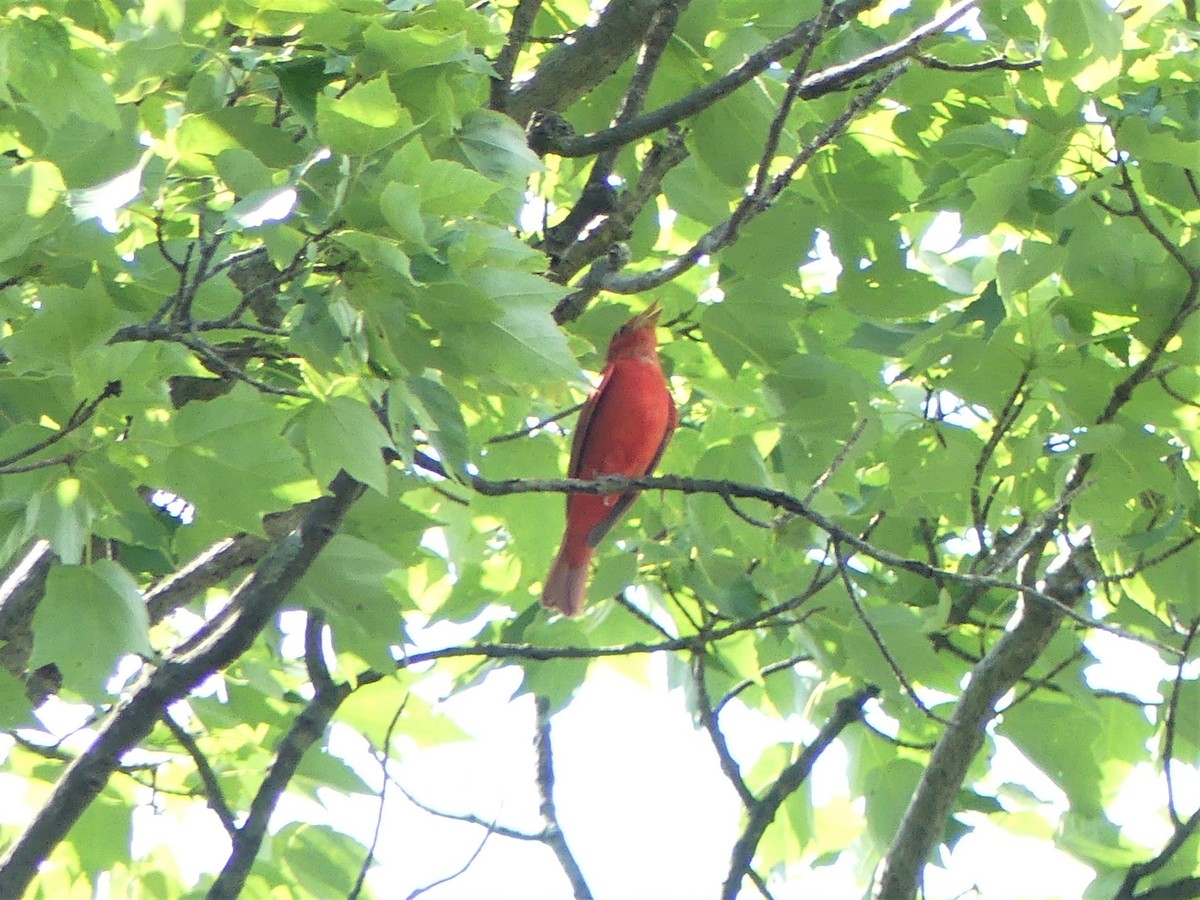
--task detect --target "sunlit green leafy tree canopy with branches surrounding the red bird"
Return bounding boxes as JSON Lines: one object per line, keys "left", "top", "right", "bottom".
{"left": 0, "top": 0, "right": 1200, "bottom": 900}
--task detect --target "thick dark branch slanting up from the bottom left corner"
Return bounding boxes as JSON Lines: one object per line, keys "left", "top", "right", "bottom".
{"left": 0, "top": 474, "right": 362, "bottom": 896}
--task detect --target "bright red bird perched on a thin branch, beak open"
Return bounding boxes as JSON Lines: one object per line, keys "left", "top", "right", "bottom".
{"left": 541, "top": 301, "right": 678, "bottom": 616}
